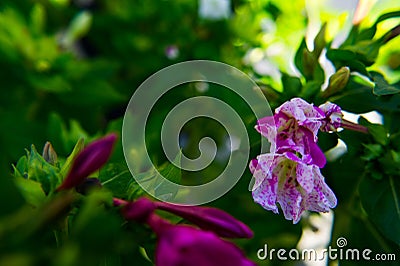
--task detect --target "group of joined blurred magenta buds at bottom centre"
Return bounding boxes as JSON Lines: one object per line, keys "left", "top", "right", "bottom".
{"left": 114, "top": 198, "right": 255, "bottom": 266}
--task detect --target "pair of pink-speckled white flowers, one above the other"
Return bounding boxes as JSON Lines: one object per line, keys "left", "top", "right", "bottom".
{"left": 249, "top": 98, "right": 342, "bottom": 223}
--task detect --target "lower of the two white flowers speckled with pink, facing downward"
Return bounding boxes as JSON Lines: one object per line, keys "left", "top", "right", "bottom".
{"left": 250, "top": 153, "right": 337, "bottom": 223}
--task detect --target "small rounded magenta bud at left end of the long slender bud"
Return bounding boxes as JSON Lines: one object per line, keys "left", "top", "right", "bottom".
{"left": 120, "top": 198, "right": 156, "bottom": 222}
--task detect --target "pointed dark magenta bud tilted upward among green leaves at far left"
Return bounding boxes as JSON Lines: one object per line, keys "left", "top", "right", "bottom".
{"left": 57, "top": 134, "right": 117, "bottom": 191}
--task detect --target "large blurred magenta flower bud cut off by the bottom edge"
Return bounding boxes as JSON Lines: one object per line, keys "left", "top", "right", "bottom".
{"left": 148, "top": 214, "right": 256, "bottom": 266}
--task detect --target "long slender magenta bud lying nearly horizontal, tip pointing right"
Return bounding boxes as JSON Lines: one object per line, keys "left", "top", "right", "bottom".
{"left": 155, "top": 202, "right": 253, "bottom": 238}
